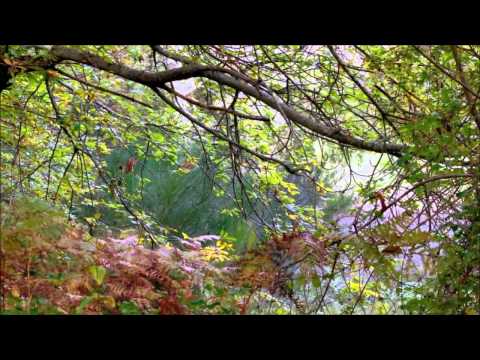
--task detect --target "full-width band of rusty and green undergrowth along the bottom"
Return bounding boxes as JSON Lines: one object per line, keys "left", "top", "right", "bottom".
{"left": 1, "top": 197, "right": 479, "bottom": 314}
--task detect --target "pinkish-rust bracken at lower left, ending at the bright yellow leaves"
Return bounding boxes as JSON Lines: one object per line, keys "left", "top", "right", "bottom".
{"left": 1, "top": 198, "right": 240, "bottom": 314}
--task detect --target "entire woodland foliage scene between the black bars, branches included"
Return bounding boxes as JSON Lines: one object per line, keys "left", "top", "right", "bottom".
{"left": 0, "top": 45, "right": 480, "bottom": 314}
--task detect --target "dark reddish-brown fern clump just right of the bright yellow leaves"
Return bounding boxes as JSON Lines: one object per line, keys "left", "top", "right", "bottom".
{"left": 230, "top": 229, "right": 328, "bottom": 314}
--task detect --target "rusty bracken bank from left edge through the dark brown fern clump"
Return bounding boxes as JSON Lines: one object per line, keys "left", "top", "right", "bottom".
{"left": 1, "top": 197, "right": 356, "bottom": 314}
